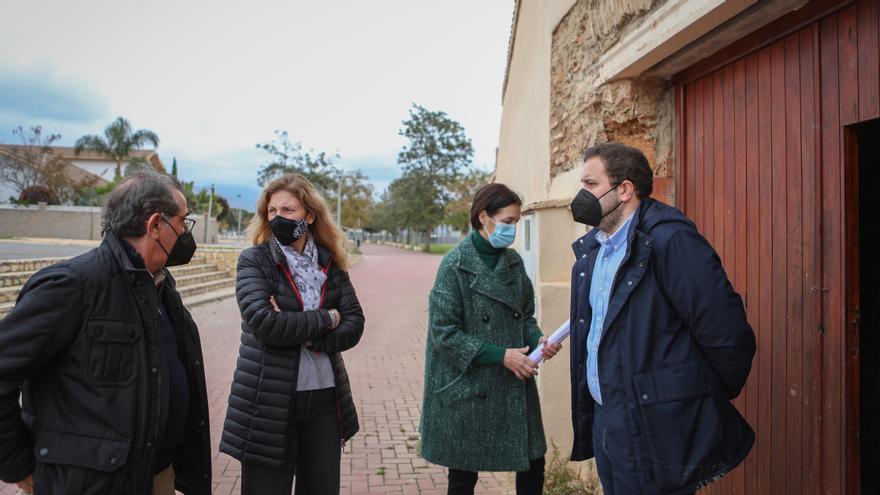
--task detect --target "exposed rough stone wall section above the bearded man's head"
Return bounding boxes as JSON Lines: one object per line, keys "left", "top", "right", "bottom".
{"left": 550, "top": 0, "right": 674, "bottom": 186}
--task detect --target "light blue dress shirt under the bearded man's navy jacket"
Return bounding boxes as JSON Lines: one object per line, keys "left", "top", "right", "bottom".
{"left": 587, "top": 210, "right": 638, "bottom": 405}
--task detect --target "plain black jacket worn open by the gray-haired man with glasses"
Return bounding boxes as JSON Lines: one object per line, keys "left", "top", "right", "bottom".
{"left": 0, "top": 233, "right": 211, "bottom": 495}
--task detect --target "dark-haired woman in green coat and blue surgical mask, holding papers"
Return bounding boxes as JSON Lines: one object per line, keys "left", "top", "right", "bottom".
{"left": 421, "top": 184, "right": 561, "bottom": 495}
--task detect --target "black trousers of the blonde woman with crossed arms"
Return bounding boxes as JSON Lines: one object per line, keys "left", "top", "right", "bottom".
{"left": 241, "top": 388, "right": 342, "bottom": 495}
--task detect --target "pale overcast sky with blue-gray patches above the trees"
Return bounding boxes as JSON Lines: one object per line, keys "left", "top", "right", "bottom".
{"left": 0, "top": 0, "right": 514, "bottom": 209}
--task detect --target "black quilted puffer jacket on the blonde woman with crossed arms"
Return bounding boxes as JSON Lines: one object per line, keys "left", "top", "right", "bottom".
{"left": 220, "top": 238, "right": 364, "bottom": 466}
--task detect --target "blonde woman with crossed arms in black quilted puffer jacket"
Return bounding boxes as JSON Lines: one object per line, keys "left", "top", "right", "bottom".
{"left": 220, "top": 174, "right": 364, "bottom": 495}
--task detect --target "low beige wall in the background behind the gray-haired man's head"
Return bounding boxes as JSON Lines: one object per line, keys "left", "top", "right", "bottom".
{"left": 0, "top": 205, "right": 217, "bottom": 244}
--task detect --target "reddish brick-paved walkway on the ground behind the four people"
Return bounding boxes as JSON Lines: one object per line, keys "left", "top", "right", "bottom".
{"left": 0, "top": 245, "right": 513, "bottom": 495}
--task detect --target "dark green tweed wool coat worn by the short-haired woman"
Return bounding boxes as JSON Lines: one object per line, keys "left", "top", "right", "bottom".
{"left": 421, "top": 237, "right": 547, "bottom": 471}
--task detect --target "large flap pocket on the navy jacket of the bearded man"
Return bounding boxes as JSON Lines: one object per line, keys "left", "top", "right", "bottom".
{"left": 633, "top": 361, "right": 723, "bottom": 488}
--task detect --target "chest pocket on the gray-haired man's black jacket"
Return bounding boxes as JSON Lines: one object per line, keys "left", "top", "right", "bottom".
{"left": 83, "top": 319, "right": 141, "bottom": 387}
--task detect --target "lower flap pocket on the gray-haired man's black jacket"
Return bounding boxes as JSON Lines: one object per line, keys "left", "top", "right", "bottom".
{"left": 34, "top": 430, "right": 131, "bottom": 495}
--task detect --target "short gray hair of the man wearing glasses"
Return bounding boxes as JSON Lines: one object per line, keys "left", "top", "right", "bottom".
{"left": 101, "top": 170, "right": 181, "bottom": 238}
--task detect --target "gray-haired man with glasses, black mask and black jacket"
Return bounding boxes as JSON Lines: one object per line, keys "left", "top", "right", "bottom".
{"left": 0, "top": 172, "right": 211, "bottom": 495}
